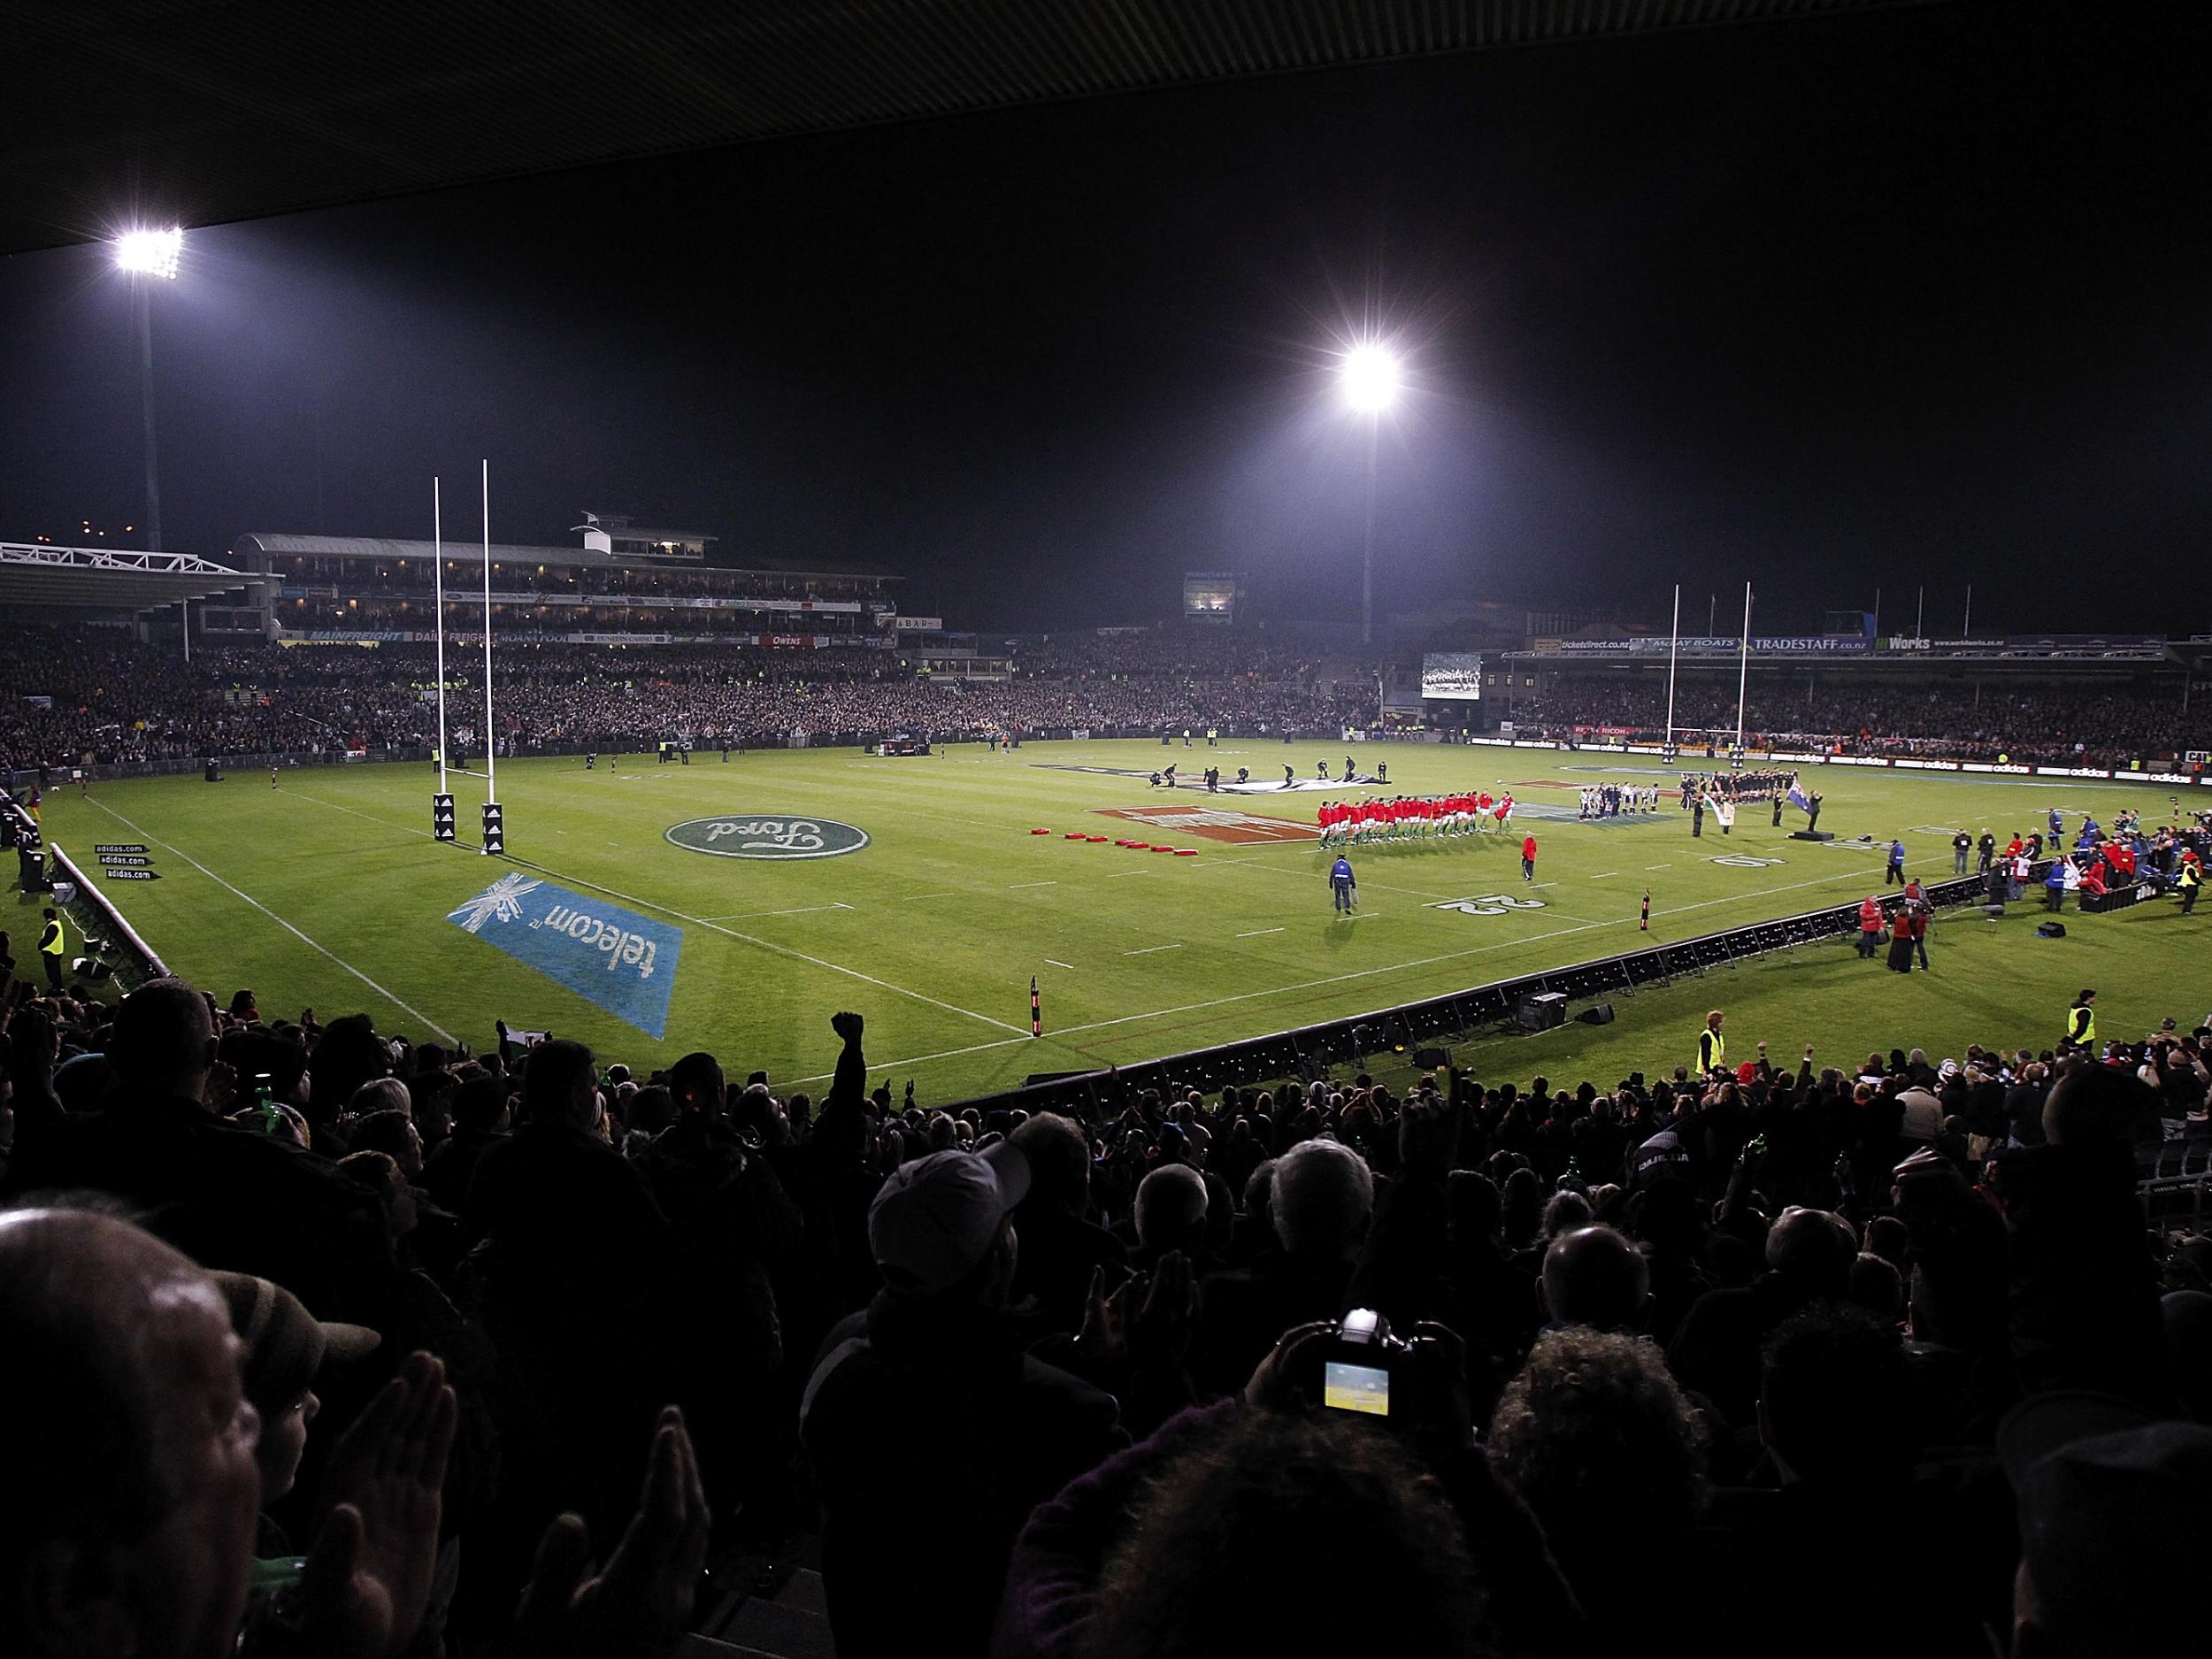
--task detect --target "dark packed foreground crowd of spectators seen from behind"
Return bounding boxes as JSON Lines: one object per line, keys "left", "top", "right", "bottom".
{"left": 0, "top": 956, "right": 2212, "bottom": 1659}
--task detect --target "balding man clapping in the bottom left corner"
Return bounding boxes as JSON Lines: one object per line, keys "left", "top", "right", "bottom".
{"left": 0, "top": 1210, "right": 454, "bottom": 1659}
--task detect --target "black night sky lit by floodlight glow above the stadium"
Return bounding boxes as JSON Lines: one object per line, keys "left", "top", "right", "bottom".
{"left": 0, "top": 3, "right": 2212, "bottom": 635}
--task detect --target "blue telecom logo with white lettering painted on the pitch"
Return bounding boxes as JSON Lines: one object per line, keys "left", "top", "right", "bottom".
{"left": 447, "top": 874, "right": 684, "bottom": 1038}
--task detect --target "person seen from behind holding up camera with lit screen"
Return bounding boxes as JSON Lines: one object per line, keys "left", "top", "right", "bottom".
{"left": 991, "top": 1308, "right": 1586, "bottom": 1659}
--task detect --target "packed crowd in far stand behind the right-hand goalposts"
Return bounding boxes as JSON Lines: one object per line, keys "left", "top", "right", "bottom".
{"left": 1513, "top": 671, "right": 2212, "bottom": 765}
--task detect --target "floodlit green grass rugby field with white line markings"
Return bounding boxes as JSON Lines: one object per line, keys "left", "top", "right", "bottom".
{"left": 30, "top": 741, "right": 2212, "bottom": 1102}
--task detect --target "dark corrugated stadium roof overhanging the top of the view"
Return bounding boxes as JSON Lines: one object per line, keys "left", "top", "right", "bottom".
{"left": 12, "top": 0, "right": 1940, "bottom": 252}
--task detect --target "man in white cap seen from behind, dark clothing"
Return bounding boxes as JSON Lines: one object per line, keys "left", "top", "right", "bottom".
{"left": 799, "top": 1141, "right": 1128, "bottom": 1659}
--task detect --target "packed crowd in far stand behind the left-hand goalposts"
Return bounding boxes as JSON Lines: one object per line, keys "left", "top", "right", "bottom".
{"left": 0, "top": 628, "right": 1374, "bottom": 770}
